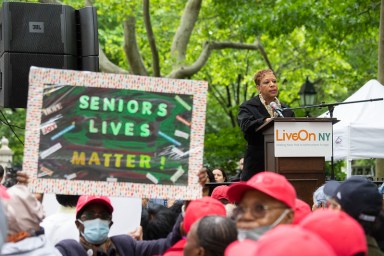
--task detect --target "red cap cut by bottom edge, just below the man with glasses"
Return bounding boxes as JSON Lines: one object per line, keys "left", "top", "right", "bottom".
{"left": 250, "top": 224, "right": 337, "bottom": 256}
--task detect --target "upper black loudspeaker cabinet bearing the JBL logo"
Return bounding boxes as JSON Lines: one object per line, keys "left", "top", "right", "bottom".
{"left": 0, "top": 2, "right": 77, "bottom": 55}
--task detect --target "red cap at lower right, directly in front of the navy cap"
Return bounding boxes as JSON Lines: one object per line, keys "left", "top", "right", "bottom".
{"left": 299, "top": 209, "right": 367, "bottom": 256}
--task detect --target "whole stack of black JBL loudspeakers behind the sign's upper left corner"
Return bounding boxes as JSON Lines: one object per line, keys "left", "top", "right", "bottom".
{"left": 0, "top": 2, "right": 99, "bottom": 108}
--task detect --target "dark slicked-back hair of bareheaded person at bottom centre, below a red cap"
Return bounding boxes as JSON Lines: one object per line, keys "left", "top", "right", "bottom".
{"left": 196, "top": 216, "right": 237, "bottom": 256}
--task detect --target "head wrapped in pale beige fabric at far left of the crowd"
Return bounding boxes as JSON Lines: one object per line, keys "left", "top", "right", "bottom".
{"left": 4, "top": 184, "right": 44, "bottom": 236}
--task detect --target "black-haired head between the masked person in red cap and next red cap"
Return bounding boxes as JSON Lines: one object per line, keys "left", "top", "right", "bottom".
{"left": 141, "top": 202, "right": 177, "bottom": 240}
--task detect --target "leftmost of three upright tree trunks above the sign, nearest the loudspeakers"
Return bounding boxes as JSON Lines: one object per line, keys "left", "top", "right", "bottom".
{"left": 124, "top": 16, "right": 148, "bottom": 76}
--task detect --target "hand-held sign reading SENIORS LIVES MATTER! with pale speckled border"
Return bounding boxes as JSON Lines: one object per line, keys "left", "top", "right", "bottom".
{"left": 23, "top": 67, "right": 207, "bottom": 199}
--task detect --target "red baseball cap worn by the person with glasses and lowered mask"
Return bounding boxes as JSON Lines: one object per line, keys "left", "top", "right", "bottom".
{"left": 228, "top": 172, "right": 296, "bottom": 209}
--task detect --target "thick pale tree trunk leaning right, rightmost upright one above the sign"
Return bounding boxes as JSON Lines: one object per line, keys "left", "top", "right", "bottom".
{"left": 171, "top": 0, "right": 202, "bottom": 66}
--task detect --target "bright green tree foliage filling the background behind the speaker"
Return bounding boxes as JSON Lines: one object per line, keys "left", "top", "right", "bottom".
{"left": 1, "top": 0, "right": 380, "bottom": 172}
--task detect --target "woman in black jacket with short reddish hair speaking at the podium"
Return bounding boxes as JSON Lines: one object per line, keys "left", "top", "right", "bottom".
{"left": 237, "top": 69, "right": 294, "bottom": 181}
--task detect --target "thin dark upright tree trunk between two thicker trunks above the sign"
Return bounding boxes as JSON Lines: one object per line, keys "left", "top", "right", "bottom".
{"left": 143, "top": 0, "right": 161, "bottom": 77}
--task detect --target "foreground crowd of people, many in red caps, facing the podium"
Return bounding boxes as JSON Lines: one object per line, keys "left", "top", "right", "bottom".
{"left": 0, "top": 169, "right": 384, "bottom": 256}
